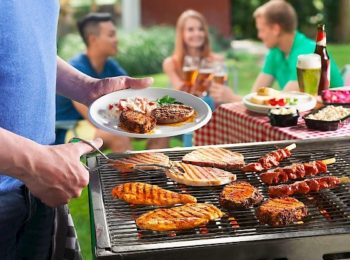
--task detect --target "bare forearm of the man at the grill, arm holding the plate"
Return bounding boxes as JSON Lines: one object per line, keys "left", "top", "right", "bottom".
{"left": 56, "top": 57, "right": 96, "bottom": 104}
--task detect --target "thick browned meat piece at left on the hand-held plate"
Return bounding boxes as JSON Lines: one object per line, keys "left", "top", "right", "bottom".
{"left": 119, "top": 110, "right": 156, "bottom": 134}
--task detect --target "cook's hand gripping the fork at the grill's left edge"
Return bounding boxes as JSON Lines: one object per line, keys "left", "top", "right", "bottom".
{"left": 22, "top": 138, "right": 102, "bottom": 207}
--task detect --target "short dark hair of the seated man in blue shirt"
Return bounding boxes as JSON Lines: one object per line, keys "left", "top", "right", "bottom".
{"left": 77, "top": 13, "right": 114, "bottom": 46}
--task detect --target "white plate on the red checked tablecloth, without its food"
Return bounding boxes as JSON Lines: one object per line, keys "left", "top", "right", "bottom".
{"left": 243, "top": 91, "right": 316, "bottom": 114}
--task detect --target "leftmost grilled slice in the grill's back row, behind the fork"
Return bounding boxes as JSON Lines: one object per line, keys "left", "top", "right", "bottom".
{"left": 111, "top": 153, "right": 170, "bottom": 173}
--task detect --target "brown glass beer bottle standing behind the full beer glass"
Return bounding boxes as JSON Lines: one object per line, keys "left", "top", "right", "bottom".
{"left": 315, "top": 24, "right": 331, "bottom": 95}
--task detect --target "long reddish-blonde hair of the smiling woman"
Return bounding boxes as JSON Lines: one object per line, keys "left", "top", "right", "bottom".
{"left": 173, "top": 10, "right": 211, "bottom": 68}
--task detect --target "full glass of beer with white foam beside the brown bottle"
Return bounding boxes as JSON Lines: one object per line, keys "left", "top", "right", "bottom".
{"left": 297, "top": 53, "right": 321, "bottom": 96}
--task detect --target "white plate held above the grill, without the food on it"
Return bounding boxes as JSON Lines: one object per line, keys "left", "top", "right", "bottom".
{"left": 89, "top": 88, "right": 211, "bottom": 138}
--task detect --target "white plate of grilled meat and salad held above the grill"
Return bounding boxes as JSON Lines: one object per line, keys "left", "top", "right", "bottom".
{"left": 89, "top": 88, "right": 212, "bottom": 138}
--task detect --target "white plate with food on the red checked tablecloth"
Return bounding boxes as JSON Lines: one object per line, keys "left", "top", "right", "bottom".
{"left": 243, "top": 87, "right": 317, "bottom": 114}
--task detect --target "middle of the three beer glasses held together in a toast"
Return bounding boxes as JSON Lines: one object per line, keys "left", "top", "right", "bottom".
{"left": 195, "top": 59, "right": 214, "bottom": 97}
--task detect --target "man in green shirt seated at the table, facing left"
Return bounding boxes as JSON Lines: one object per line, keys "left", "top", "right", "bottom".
{"left": 252, "top": 0, "right": 344, "bottom": 92}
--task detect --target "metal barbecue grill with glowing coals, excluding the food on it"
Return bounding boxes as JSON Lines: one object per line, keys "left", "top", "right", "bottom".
{"left": 88, "top": 137, "right": 350, "bottom": 260}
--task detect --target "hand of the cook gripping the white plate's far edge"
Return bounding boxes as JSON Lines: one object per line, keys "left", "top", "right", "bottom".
{"left": 85, "top": 76, "right": 153, "bottom": 105}
